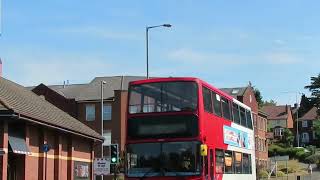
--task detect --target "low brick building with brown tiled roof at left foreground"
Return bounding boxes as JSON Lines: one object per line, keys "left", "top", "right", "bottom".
{"left": 0, "top": 77, "right": 103, "bottom": 180}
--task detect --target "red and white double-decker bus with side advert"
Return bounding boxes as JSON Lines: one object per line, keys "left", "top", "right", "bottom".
{"left": 125, "top": 78, "right": 256, "bottom": 180}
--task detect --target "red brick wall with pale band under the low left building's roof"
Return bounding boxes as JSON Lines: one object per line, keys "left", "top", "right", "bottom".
{"left": 0, "top": 121, "right": 94, "bottom": 180}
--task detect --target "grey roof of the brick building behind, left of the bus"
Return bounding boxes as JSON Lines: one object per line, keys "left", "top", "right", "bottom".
{"left": 32, "top": 76, "right": 146, "bottom": 101}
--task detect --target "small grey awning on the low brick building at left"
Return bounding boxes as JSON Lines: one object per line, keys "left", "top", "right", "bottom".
{"left": 9, "top": 133, "right": 31, "bottom": 155}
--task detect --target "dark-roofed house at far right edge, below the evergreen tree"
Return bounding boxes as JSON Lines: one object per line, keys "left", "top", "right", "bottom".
{"left": 298, "top": 107, "right": 318, "bottom": 146}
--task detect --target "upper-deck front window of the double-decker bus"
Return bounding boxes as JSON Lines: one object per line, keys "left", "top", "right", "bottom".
{"left": 129, "top": 81, "right": 198, "bottom": 114}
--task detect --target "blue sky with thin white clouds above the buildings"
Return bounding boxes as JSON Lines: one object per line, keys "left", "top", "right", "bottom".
{"left": 0, "top": 0, "right": 320, "bottom": 104}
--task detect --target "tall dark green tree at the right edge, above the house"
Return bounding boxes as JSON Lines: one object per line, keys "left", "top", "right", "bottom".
{"left": 304, "top": 73, "right": 320, "bottom": 114}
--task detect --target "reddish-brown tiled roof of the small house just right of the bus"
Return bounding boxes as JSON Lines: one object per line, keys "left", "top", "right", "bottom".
{"left": 262, "top": 105, "right": 290, "bottom": 120}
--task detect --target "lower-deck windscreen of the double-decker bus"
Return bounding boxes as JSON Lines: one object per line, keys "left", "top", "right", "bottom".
{"left": 127, "top": 141, "right": 201, "bottom": 178}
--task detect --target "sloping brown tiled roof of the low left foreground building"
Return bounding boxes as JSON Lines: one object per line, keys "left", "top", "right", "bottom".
{"left": 0, "top": 77, "right": 103, "bottom": 140}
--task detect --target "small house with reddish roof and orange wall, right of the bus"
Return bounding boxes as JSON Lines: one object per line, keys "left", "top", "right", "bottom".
{"left": 262, "top": 105, "right": 293, "bottom": 139}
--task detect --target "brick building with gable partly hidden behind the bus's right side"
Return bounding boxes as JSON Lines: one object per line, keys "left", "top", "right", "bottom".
{"left": 221, "top": 86, "right": 268, "bottom": 168}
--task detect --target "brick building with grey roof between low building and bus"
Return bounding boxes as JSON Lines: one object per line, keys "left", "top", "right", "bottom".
{"left": 29, "top": 76, "right": 145, "bottom": 177}
